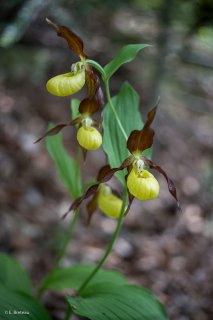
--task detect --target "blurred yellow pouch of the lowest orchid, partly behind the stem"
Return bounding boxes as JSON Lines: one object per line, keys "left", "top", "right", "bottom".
{"left": 98, "top": 184, "right": 122, "bottom": 219}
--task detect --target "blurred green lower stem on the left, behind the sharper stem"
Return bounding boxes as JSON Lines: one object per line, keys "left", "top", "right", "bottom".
{"left": 38, "top": 211, "right": 79, "bottom": 298}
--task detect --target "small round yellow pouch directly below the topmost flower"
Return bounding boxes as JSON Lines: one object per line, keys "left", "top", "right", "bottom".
{"left": 77, "top": 126, "right": 102, "bottom": 150}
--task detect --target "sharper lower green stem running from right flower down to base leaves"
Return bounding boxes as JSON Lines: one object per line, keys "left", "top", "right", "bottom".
{"left": 77, "top": 189, "right": 127, "bottom": 295}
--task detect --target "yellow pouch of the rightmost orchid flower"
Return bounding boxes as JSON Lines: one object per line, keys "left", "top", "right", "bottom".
{"left": 127, "top": 168, "right": 160, "bottom": 200}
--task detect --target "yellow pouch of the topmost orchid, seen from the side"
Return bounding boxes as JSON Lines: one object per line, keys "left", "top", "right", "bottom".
{"left": 46, "top": 62, "right": 85, "bottom": 97}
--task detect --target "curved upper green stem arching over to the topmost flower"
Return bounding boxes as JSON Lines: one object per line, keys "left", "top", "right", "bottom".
{"left": 87, "top": 60, "right": 128, "bottom": 140}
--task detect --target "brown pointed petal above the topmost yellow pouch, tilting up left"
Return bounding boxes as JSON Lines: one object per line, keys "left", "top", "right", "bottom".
{"left": 46, "top": 19, "right": 87, "bottom": 59}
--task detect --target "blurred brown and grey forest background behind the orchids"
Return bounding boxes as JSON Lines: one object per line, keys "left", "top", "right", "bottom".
{"left": 0, "top": 0, "right": 213, "bottom": 320}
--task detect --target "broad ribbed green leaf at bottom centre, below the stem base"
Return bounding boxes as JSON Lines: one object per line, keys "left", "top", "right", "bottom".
{"left": 67, "top": 283, "right": 168, "bottom": 320}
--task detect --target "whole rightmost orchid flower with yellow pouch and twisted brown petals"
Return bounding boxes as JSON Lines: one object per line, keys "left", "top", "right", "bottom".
{"left": 64, "top": 103, "right": 180, "bottom": 221}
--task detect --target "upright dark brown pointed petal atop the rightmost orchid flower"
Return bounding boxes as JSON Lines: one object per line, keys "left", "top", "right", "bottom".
{"left": 127, "top": 100, "right": 159, "bottom": 153}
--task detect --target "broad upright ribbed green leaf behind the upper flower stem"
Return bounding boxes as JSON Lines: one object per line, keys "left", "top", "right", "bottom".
{"left": 103, "top": 83, "right": 143, "bottom": 184}
